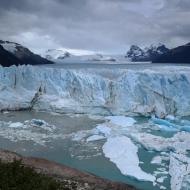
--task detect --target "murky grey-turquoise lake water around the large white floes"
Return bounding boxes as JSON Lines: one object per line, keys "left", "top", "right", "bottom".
{"left": 0, "top": 111, "right": 189, "bottom": 190}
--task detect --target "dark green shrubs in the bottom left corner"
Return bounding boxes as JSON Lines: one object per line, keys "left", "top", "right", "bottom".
{"left": 0, "top": 161, "right": 74, "bottom": 190}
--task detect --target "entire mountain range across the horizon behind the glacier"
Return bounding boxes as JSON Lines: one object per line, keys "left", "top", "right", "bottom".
{"left": 0, "top": 40, "right": 190, "bottom": 67}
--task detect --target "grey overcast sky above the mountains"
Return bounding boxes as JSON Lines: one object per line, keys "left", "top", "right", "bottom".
{"left": 0, "top": 0, "right": 190, "bottom": 53}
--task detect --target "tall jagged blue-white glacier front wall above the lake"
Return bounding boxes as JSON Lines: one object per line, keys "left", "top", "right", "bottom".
{"left": 0, "top": 66, "right": 190, "bottom": 118}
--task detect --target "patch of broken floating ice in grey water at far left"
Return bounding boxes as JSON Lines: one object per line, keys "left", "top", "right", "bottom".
{"left": 0, "top": 119, "right": 60, "bottom": 146}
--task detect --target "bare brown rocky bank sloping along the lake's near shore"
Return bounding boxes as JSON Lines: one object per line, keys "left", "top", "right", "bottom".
{"left": 0, "top": 150, "right": 135, "bottom": 190}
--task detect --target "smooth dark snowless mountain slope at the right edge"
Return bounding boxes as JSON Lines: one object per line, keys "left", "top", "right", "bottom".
{"left": 153, "top": 43, "right": 190, "bottom": 63}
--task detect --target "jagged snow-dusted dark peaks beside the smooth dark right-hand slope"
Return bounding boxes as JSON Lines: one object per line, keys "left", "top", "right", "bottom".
{"left": 125, "top": 44, "right": 169, "bottom": 61}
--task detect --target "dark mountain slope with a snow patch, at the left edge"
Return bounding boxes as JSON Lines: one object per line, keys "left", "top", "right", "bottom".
{"left": 0, "top": 40, "right": 53, "bottom": 66}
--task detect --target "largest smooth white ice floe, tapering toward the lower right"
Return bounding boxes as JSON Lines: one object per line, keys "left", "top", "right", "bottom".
{"left": 102, "top": 136, "right": 155, "bottom": 182}
